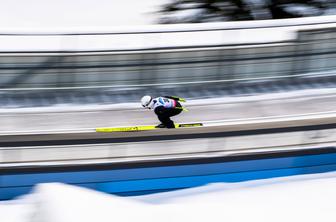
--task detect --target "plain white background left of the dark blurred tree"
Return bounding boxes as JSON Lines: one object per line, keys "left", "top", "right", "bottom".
{"left": 0, "top": 0, "right": 165, "bottom": 29}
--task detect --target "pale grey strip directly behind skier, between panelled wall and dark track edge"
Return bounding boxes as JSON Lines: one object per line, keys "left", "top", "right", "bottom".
{"left": 0, "top": 89, "right": 336, "bottom": 134}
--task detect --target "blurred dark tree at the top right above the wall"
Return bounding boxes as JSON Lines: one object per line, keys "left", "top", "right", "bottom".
{"left": 159, "top": 0, "right": 336, "bottom": 23}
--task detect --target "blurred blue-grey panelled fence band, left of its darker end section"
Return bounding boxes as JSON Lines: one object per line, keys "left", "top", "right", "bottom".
{"left": 0, "top": 43, "right": 298, "bottom": 88}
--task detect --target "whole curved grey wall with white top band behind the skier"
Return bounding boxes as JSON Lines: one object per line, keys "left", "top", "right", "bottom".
{"left": 0, "top": 16, "right": 336, "bottom": 107}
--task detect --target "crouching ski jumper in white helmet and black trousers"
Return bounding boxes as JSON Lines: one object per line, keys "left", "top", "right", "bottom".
{"left": 141, "top": 95, "right": 186, "bottom": 128}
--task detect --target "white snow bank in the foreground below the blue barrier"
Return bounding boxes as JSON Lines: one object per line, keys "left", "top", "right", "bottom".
{"left": 0, "top": 172, "right": 336, "bottom": 222}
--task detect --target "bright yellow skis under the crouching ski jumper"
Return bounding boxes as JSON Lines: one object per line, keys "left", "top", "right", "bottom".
{"left": 96, "top": 123, "right": 203, "bottom": 133}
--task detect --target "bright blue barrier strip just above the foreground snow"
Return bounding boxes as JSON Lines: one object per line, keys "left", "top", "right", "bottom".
{"left": 0, "top": 153, "right": 336, "bottom": 200}
